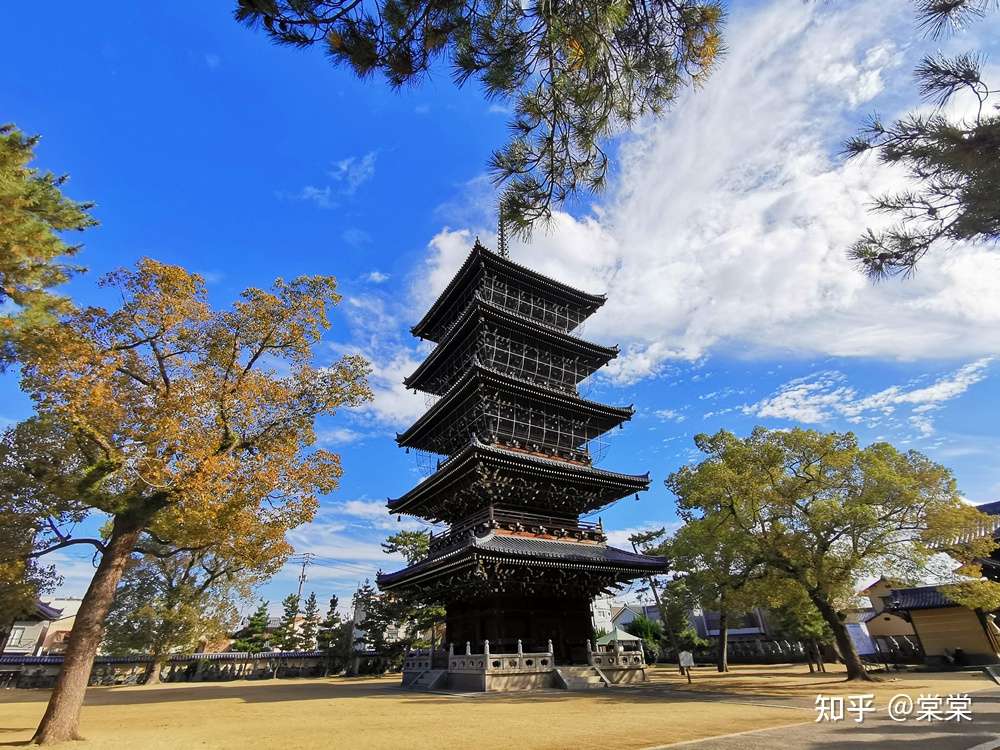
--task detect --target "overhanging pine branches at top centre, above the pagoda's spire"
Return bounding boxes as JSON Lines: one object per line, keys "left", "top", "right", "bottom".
{"left": 236, "top": 0, "right": 723, "bottom": 233}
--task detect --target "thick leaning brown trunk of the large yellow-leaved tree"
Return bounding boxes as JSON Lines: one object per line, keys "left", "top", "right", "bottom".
{"left": 33, "top": 515, "right": 144, "bottom": 745}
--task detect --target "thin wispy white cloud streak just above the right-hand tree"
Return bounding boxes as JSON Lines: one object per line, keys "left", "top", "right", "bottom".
{"left": 742, "top": 357, "right": 992, "bottom": 437}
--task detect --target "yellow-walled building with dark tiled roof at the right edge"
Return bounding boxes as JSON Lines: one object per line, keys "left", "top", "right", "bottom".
{"left": 889, "top": 586, "right": 1000, "bottom": 664}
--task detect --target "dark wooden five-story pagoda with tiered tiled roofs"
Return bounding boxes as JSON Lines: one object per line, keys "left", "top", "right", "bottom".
{"left": 378, "top": 240, "right": 665, "bottom": 680}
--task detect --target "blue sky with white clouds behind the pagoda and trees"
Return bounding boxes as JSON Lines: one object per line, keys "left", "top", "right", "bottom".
{"left": 0, "top": 0, "right": 1000, "bottom": 606}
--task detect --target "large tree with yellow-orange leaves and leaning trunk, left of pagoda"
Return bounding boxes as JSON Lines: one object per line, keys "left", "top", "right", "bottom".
{"left": 10, "top": 259, "right": 371, "bottom": 744}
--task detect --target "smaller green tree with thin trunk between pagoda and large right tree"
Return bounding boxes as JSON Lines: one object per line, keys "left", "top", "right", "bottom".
{"left": 660, "top": 511, "right": 763, "bottom": 672}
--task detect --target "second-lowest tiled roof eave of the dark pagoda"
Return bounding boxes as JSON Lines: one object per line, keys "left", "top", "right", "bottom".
{"left": 386, "top": 439, "right": 650, "bottom": 515}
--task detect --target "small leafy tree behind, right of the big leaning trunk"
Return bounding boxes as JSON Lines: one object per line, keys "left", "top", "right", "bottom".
{"left": 104, "top": 549, "right": 256, "bottom": 684}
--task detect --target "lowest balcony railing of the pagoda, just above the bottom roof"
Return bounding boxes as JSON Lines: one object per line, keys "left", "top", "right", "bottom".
{"left": 428, "top": 505, "right": 608, "bottom": 557}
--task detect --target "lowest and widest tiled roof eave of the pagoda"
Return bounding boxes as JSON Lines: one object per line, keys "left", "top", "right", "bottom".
{"left": 377, "top": 533, "right": 669, "bottom": 589}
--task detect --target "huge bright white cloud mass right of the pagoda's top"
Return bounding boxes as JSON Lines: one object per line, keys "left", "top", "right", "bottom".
{"left": 416, "top": 0, "right": 1000, "bottom": 382}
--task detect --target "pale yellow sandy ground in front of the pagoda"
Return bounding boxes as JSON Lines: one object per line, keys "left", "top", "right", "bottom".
{"left": 0, "top": 666, "right": 996, "bottom": 750}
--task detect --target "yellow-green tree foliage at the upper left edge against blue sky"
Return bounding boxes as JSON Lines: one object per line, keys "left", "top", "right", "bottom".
{"left": 0, "top": 125, "right": 97, "bottom": 368}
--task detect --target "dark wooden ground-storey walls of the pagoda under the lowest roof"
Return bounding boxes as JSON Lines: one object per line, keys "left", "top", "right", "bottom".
{"left": 444, "top": 593, "right": 594, "bottom": 664}
